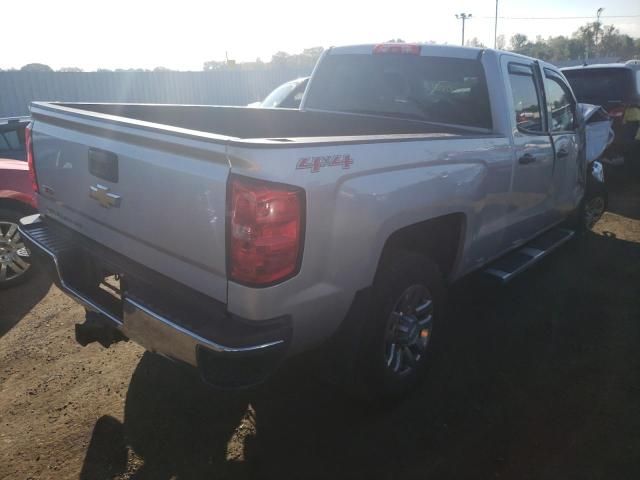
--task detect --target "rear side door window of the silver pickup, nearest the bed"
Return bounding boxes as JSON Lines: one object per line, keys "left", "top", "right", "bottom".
{"left": 509, "top": 63, "right": 543, "bottom": 133}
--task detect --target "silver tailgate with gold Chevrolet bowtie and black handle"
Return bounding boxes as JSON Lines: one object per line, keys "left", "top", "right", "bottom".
{"left": 32, "top": 107, "right": 229, "bottom": 302}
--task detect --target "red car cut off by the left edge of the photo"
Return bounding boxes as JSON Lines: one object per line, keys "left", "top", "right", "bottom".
{"left": 0, "top": 119, "right": 36, "bottom": 289}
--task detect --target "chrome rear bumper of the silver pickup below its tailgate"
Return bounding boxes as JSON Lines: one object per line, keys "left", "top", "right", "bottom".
{"left": 19, "top": 214, "right": 288, "bottom": 386}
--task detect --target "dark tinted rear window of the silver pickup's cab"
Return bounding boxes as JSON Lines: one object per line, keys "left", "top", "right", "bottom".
{"left": 306, "top": 54, "right": 491, "bottom": 129}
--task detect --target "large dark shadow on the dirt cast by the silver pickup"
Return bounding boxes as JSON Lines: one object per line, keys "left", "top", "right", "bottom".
{"left": 81, "top": 227, "right": 640, "bottom": 479}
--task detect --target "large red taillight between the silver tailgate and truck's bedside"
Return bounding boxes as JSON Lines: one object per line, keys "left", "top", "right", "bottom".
{"left": 227, "top": 176, "right": 305, "bottom": 286}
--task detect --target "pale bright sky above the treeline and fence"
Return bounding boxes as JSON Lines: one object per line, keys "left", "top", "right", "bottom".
{"left": 0, "top": 0, "right": 640, "bottom": 71}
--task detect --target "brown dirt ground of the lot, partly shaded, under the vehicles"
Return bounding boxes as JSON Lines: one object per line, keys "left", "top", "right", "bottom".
{"left": 0, "top": 171, "right": 640, "bottom": 479}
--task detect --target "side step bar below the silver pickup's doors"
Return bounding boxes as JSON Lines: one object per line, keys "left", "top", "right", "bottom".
{"left": 484, "top": 228, "right": 575, "bottom": 283}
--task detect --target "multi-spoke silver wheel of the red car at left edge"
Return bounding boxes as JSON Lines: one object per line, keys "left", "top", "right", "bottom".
{"left": 0, "top": 208, "right": 33, "bottom": 288}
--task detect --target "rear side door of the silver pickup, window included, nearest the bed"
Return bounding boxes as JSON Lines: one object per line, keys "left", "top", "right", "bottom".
{"left": 502, "top": 56, "right": 554, "bottom": 247}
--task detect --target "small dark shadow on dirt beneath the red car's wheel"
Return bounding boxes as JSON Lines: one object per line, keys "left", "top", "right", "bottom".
{"left": 0, "top": 269, "right": 51, "bottom": 338}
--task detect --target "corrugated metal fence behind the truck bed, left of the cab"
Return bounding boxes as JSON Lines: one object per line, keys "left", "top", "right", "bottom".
{"left": 0, "top": 67, "right": 311, "bottom": 117}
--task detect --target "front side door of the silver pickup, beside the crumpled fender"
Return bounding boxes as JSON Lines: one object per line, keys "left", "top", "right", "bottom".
{"left": 544, "top": 68, "right": 585, "bottom": 220}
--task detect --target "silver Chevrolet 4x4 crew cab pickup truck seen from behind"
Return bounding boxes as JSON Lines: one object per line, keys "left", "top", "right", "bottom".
{"left": 21, "top": 44, "right": 586, "bottom": 398}
